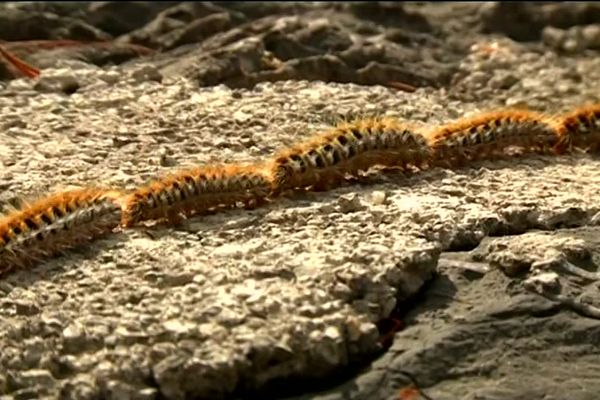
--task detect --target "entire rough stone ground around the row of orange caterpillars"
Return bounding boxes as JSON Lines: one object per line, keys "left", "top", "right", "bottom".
{"left": 0, "top": 2, "right": 600, "bottom": 400}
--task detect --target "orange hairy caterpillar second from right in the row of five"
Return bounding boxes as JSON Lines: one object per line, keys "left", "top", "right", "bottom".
{"left": 429, "top": 110, "right": 558, "bottom": 166}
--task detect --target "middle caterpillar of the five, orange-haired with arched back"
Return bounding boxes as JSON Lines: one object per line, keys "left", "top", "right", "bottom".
{"left": 270, "top": 118, "right": 429, "bottom": 191}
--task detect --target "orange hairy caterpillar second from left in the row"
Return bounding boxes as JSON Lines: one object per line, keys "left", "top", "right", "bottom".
{"left": 122, "top": 164, "right": 273, "bottom": 227}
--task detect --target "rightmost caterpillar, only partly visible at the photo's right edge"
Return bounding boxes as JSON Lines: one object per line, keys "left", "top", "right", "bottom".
{"left": 556, "top": 103, "right": 600, "bottom": 153}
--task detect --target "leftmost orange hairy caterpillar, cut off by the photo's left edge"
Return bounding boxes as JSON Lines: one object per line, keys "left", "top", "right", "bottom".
{"left": 0, "top": 188, "right": 121, "bottom": 275}
